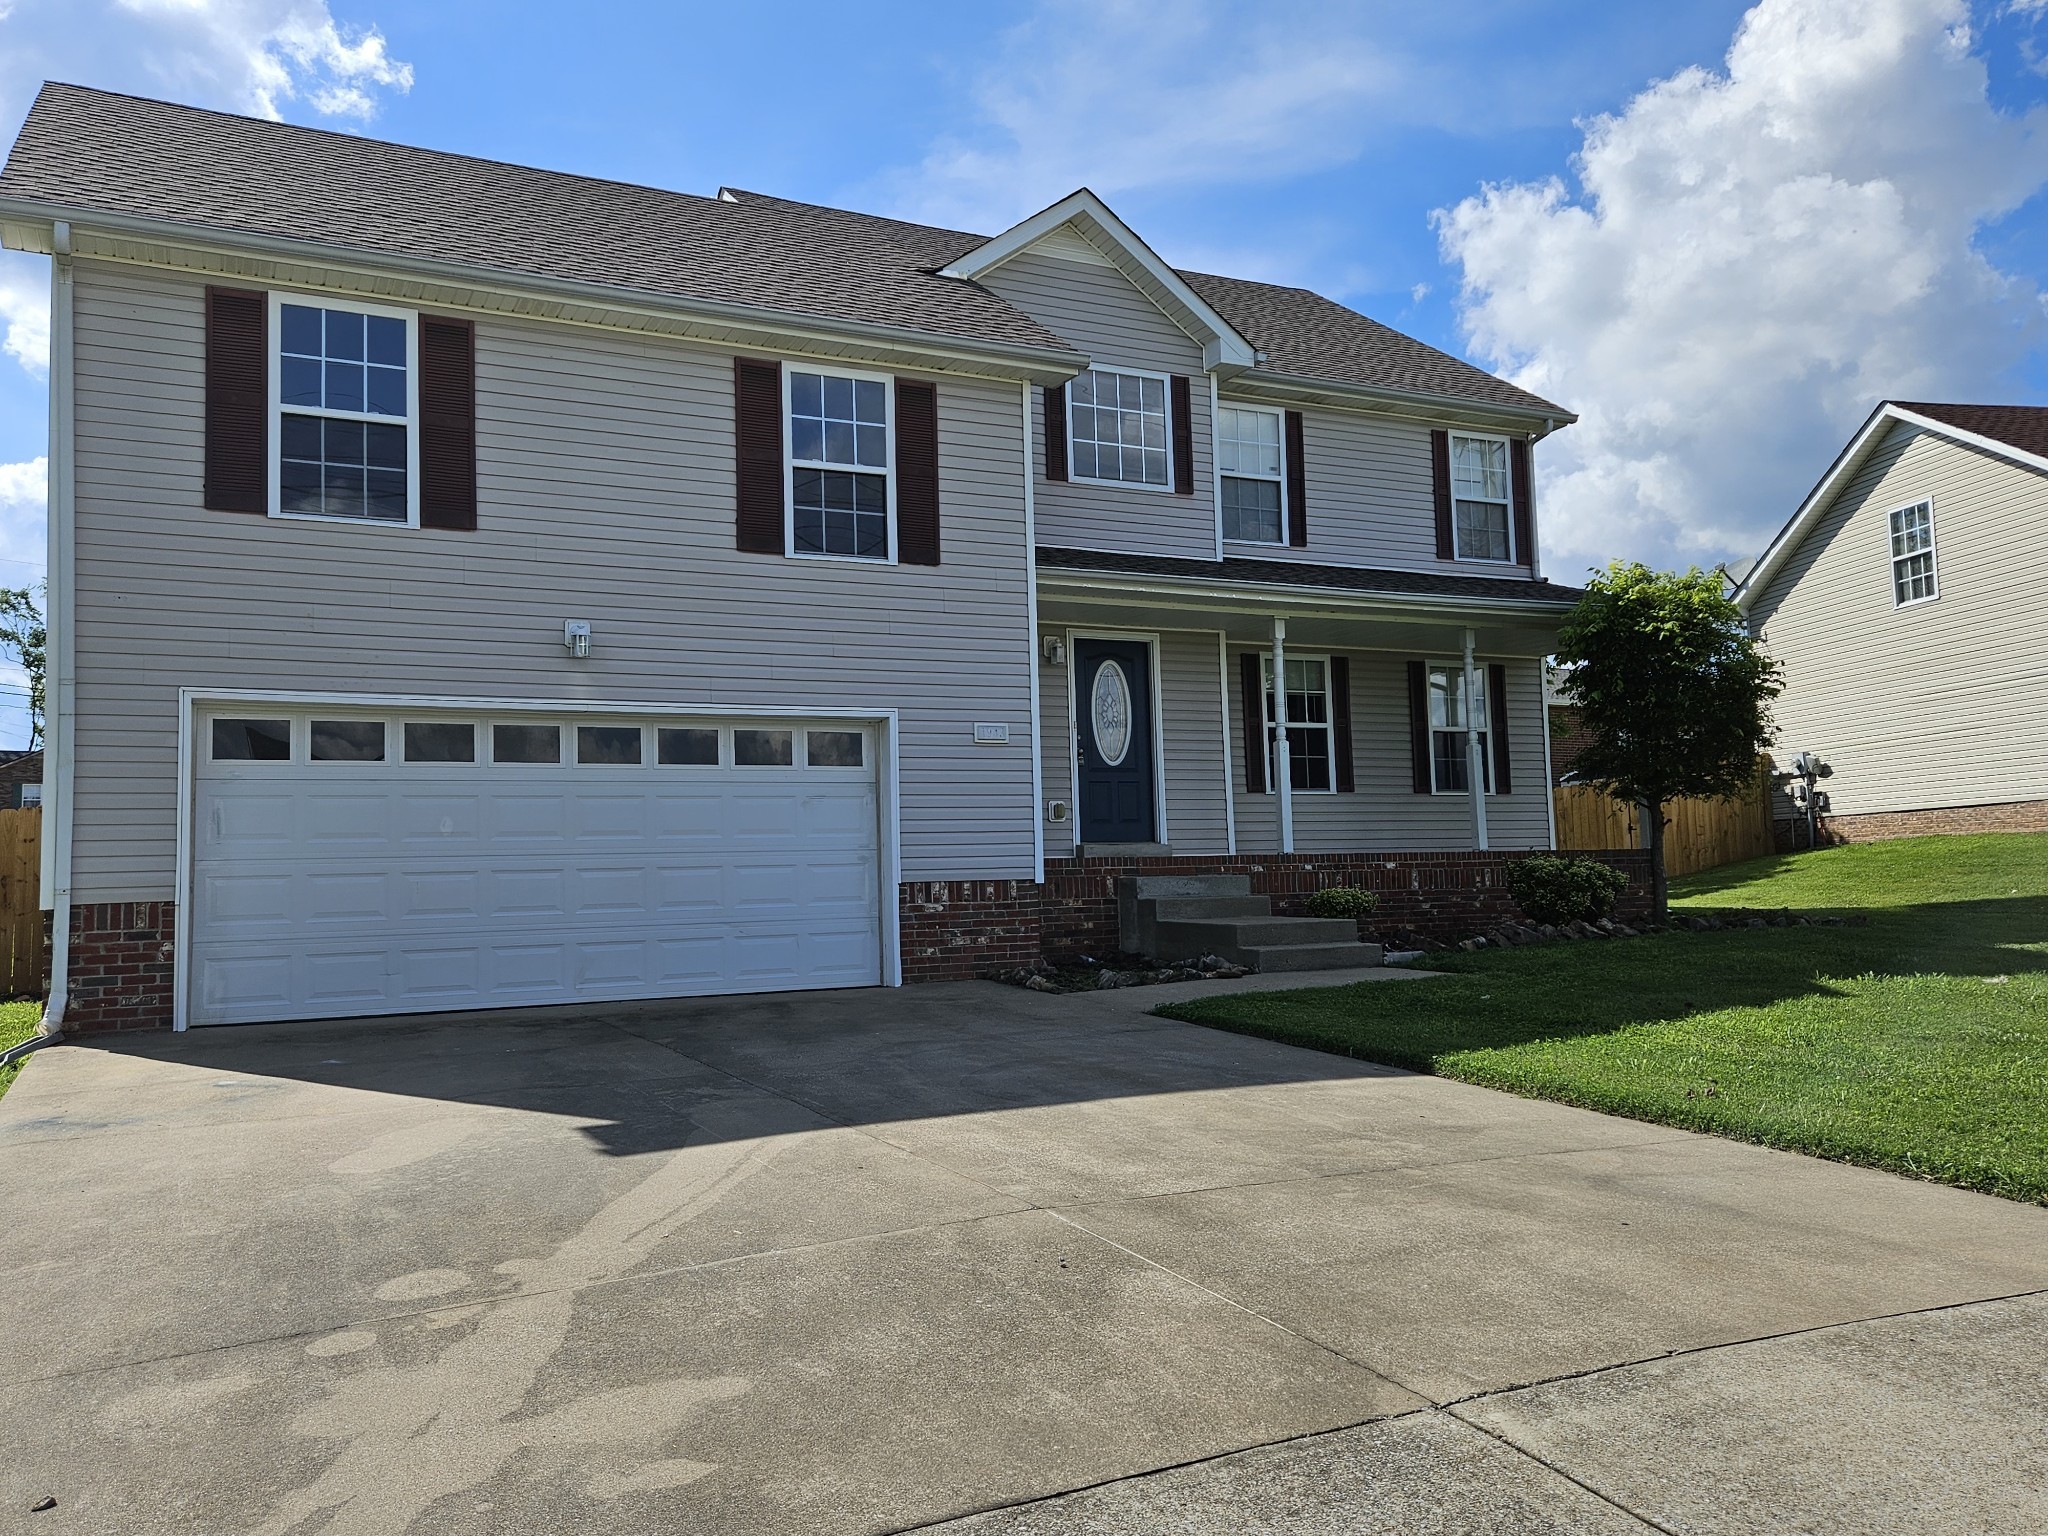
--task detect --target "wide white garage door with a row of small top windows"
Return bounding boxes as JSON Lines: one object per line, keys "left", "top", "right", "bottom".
{"left": 188, "top": 707, "right": 883, "bottom": 1024}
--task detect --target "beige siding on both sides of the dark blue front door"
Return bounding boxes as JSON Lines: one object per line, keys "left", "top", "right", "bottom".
{"left": 1038, "top": 625, "right": 1231, "bottom": 858}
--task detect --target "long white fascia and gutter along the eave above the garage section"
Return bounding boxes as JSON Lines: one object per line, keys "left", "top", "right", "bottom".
{"left": 0, "top": 197, "right": 1090, "bottom": 385}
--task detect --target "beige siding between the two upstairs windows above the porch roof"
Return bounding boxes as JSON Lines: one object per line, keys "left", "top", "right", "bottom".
{"left": 1221, "top": 405, "right": 1530, "bottom": 580}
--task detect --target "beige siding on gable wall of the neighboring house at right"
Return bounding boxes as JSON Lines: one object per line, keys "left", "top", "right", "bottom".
{"left": 1751, "top": 424, "right": 2048, "bottom": 815}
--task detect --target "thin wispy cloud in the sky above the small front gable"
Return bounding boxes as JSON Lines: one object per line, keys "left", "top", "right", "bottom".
{"left": 885, "top": 0, "right": 1442, "bottom": 229}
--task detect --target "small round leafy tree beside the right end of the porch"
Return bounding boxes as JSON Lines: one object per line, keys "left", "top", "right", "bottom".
{"left": 1556, "top": 561, "right": 1782, "bottom": 922}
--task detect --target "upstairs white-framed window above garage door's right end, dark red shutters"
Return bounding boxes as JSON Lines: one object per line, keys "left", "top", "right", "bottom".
{"left": 784, "top": 367, "right": 895, "bottom": 559}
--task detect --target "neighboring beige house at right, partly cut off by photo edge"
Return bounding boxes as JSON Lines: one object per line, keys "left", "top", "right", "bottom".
{"left": 1737, "top": 401, "right": 2048, "bottom": 840}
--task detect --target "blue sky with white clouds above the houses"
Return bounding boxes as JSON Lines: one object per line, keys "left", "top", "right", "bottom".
{"left": 0, "top": 0, "right": 2048, "bottom": 743}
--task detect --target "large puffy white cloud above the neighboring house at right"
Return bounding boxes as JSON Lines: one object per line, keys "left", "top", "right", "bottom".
{"left": 1438, "top": 0, "right": 2048, "bottom": 578}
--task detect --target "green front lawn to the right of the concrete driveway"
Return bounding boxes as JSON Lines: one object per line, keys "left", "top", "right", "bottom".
{"left": 1159, "top": 834, "right": 2048, "bottom": 1204}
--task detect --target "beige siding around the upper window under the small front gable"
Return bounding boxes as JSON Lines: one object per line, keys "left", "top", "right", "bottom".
{"left": 983, "top": 252, "right": 1217, "bottom": 559}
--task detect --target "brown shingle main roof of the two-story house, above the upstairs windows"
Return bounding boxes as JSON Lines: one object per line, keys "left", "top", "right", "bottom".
{"left": 0, "top": 84, "right": 1569, "bottom": 416}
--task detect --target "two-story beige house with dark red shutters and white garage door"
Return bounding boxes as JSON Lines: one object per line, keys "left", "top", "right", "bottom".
{"left": 0, "top": 86, "right": 1577, "bottom": 1026}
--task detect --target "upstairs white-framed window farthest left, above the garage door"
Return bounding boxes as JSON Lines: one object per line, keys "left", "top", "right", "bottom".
{"left": 270, "top": 293, "right": 420, "bottom": 524}
